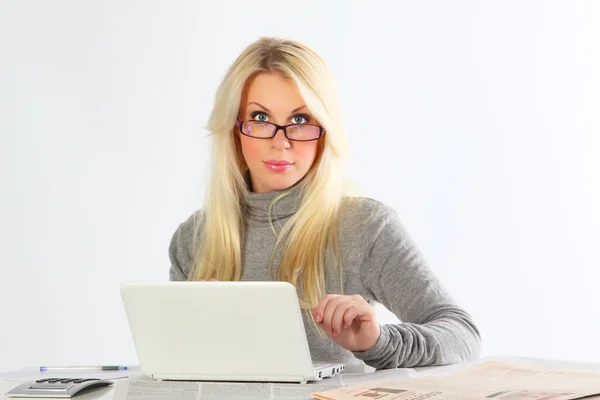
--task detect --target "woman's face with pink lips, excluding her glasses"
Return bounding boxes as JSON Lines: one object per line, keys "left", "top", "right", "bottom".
{"left": 235, "top": 73, "right": 320, "bottom": 193}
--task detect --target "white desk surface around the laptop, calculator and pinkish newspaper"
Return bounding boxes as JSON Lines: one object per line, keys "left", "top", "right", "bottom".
{"left": 0, "top": 356, "right": 600, "bottom": 400}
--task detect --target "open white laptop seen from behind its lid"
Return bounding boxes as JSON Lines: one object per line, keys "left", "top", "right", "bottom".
{"left": 121, "top": 282, "right": 344, "bottom": 383}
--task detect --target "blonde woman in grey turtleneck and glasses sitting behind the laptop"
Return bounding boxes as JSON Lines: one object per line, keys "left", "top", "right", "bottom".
{"left": 169, "top": 38, "right": 480, "bottom": 368}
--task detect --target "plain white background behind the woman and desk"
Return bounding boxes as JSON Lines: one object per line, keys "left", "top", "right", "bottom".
{"left": 0, "top": 0, "right": 600, "bottom": 370}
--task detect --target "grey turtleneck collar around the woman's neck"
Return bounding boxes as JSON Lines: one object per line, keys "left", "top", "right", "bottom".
{"left": 244, "top": 171, "right": 301, "bottom": 222}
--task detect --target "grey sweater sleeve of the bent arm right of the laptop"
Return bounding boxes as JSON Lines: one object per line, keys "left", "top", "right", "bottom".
{"left": 354, "top": 205, "right": 481, "bottom": 368}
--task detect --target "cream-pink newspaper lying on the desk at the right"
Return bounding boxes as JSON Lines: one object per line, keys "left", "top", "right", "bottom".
{"left": 313, "top": 361, "right": 600, "bottom": 400}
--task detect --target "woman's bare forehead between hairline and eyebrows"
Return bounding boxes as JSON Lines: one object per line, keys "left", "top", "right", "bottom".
{"left": 242, "top": 73, "right": 304, "bottom": 113}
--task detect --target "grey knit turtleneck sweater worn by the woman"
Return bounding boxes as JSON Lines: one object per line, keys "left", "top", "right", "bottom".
{"left": 169, "top": 192, "right": 480, "bottom": 368}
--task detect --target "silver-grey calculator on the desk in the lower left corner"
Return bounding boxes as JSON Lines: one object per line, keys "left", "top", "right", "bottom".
{"left": 6, "top": 378, "right": 113, "bottom": 399}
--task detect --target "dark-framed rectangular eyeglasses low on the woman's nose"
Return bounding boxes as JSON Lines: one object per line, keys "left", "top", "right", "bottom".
{"left": 237, "top": 120, "right": 325, "bottom": 142}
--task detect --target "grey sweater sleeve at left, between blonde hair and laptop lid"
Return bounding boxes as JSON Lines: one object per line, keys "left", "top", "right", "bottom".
{"left": 169, "top": 212, "right": 200, "bottom": 281}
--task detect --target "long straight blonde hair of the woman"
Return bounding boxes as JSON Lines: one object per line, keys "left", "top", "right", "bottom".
{"left": 190, "top": 38, "right": 346, "bottom": 309}
